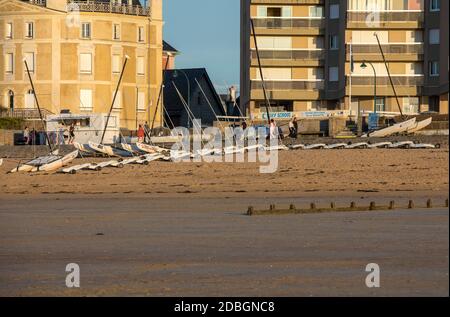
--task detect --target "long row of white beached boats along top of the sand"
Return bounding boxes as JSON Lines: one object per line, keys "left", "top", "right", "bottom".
{"left": 6, "top": 136, "right": 440, "bottom": 174}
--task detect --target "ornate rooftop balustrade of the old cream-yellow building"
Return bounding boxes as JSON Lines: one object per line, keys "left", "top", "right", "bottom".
{"left": 68, "top": 1, "right": 151, "bottom": 16}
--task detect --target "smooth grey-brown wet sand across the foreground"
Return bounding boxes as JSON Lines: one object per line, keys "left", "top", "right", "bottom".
{"left": 0, "top": 196, "right": 449, "bottom": 296}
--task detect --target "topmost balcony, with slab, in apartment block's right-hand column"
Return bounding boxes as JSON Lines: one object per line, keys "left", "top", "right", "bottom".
{"left": 347, "top": 11, "right": 424, "bottom": 29}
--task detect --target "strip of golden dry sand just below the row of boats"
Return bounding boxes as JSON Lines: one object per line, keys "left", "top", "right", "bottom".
{"left": 0, "top": 149, "right": 449, "bottom": 197}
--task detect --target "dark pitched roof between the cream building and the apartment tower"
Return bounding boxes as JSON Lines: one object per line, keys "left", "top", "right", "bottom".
{"left": 164, "top": 68, "right": 225, "bottom": 115}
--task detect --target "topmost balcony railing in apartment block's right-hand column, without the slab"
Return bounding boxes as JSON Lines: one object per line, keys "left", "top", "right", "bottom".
{"left": 347, "top": 11, "right": 424, "bottom": 26}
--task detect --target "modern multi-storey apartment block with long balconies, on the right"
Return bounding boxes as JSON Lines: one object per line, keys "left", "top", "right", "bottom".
{"left": 241, "top": 0, "right": 449, "bottom": 118}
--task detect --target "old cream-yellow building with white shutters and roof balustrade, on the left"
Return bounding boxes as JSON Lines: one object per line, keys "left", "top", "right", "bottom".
{"left": 0, "top": 0, "right": 163, "bottom": 129}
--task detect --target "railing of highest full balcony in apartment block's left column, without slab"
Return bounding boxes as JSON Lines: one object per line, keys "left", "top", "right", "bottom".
{"left": 253, "top": 18, "right": 325, "bottom": 29}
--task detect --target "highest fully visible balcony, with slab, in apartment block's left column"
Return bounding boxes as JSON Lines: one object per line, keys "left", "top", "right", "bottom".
{"left": 253, "top": 17, "right": 325, "bottom": 35}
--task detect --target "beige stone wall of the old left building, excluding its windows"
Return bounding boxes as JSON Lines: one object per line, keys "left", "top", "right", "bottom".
{"left": 0, "top": 0, "right": 163, "bottom": 129}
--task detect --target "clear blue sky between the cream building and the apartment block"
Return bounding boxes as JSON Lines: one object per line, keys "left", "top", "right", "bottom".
{"left": 163, "top": 0, "right": 240, "bottom": 92}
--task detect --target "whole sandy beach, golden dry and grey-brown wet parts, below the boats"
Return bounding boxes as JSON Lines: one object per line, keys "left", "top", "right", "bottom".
{"left": 0, "top": 149, "right": 449, "bottom": 296}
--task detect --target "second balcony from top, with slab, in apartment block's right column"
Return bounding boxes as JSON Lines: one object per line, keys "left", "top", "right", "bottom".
{"left": 347, "top": 43, "right": 424, "bottom": 62}
